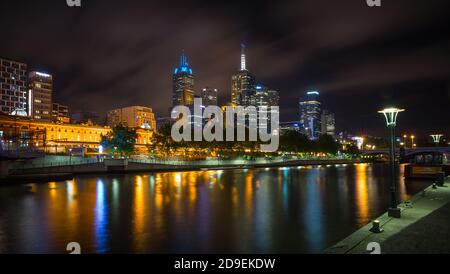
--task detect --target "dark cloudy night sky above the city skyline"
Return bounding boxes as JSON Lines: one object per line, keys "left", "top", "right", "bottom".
{"left": 0, "top": 0, "right": 450, "bottom": 139}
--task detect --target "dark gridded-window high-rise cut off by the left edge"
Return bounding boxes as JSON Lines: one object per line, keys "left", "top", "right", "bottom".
{"left": 0, "top": 58, "right": 28, "bottom": 116}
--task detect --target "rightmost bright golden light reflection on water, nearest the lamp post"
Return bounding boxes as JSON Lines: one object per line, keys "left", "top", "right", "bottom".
{"left": 356, "top": 164, "right": 369, "bottom": 220}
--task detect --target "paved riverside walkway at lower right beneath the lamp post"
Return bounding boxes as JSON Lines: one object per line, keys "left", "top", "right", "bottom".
{"left": 324, "top": 177, "right": 450, "bottom": 254}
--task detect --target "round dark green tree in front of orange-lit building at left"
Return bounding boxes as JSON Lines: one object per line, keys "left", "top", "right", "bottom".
{"left": 101, "top": 124, "right": 137, "bottom": 156}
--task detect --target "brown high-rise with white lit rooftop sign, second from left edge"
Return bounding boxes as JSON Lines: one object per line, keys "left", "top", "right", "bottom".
{"left": 28, "top": 71, "right": 53, "bottom": 122}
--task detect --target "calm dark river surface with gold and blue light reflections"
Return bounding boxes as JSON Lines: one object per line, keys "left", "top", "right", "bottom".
{"left": 0, "top": 164, "right": 430, "bottom": 253}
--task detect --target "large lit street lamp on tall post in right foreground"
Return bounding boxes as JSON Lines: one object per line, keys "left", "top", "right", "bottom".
{"left": 378, "top": 108, "right": 405, "bottom": 218}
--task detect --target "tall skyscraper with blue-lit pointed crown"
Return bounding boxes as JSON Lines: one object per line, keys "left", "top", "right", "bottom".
{"left": 172, "top": 51, "right": 194, "bottom": 107}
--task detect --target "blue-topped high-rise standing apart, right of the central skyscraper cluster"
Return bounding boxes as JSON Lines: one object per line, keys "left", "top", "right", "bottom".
{"left": 299, "top": 91, "right": 322, "bottom": 139}
